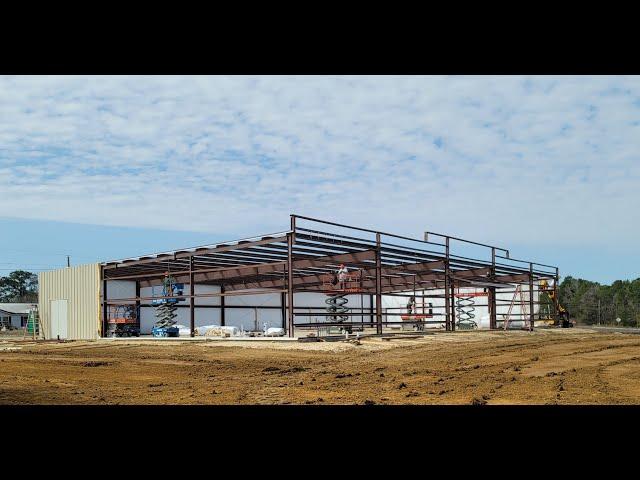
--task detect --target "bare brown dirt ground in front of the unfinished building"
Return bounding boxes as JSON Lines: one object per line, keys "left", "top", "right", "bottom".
{"left": 0, "top": 328, "right": 640, "bottom": 405}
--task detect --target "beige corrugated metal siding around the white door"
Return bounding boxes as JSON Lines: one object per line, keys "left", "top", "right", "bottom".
{"left": 38, "top": 263, "right": 101, "bottom": 340}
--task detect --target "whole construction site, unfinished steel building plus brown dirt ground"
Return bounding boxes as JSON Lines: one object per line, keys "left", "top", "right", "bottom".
{"left": 0, "top": 215, "right": 640, "bottom": 404}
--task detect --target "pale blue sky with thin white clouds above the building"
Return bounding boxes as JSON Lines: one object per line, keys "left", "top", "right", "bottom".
{"left": 0, "top": 76, "right": 640, "bottom": 283}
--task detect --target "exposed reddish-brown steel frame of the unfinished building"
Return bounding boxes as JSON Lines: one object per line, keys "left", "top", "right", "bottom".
{"left": 101, "top": 215, "right": 559, "bottom": 337}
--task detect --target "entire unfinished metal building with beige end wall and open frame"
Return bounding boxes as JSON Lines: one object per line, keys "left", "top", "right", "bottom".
{"left": 39, "top": 215, "right": 572, "bottom": 340}
